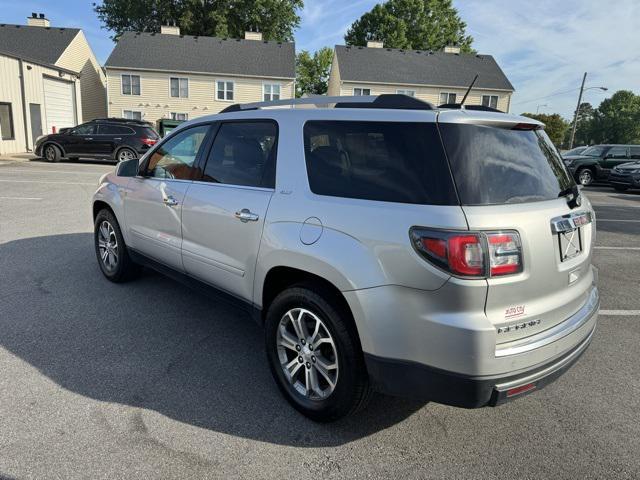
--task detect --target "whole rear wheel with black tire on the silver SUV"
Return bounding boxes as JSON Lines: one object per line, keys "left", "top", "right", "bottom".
{"left": 265, "top": 284, "right": 371, "bottom": 422}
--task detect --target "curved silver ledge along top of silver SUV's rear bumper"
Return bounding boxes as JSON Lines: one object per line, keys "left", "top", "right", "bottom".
{"left": 496, "top": 287, "right": 600, "bottom": 358}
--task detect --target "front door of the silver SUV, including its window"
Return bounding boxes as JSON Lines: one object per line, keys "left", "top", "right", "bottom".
{"left": 124, "top": 124, "right": 211, "bottom": 271}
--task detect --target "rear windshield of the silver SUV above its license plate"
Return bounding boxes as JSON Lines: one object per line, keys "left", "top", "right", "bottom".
{"left": 440, "top": 123, "right": 574, "bottom": 205}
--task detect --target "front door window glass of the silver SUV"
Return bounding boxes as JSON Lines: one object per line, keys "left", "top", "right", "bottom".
{"left": 146, "top": 125, "right": 209, "bottom": 180}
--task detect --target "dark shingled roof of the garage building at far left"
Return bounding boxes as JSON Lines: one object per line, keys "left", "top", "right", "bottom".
{"left": 0, "top": 23, "right": 80, "bottom": 65}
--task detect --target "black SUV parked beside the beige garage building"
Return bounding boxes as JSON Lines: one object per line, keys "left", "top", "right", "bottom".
{"left": 35, "top": 118, "right": 159, "bottom": 162}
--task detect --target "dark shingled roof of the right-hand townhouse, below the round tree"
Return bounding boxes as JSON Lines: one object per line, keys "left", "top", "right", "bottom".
{"left": 336, "top": 45, "right": 514, "bottom": 90}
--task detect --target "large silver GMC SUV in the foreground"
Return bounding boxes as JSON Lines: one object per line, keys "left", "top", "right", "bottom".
{"left": 93, "top": 95, "right": 599, "bottom": 421}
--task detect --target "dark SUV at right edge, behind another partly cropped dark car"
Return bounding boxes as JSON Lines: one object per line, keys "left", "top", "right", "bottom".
{"left": 564, "top": 145, "right": 640, "bottom": 185}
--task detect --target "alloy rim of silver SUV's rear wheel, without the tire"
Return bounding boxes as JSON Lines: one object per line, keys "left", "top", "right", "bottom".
{"left": 276, "top": 308, "right": 339, "bottom": 401}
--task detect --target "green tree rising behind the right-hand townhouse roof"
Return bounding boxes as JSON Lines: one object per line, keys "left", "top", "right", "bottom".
{"left": 344, "top": 0, "right": 473, "bottom": 53}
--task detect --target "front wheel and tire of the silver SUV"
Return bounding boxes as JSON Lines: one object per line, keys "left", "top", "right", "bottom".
{"left": 93, "top": 209, "right": 140, "bottom": 283}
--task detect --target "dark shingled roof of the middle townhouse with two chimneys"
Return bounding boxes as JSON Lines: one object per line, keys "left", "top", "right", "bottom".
{"left": 105, "top": 32, "right": 295, "bottom": 78}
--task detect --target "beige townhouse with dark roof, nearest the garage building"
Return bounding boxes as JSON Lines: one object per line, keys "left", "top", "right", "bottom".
{"left": 105, "top": 26, "right": 295, "bottom": 123}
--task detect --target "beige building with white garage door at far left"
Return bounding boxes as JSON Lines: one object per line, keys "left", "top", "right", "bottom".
{"left": 0, "top": 13, "right": 107, "bottom": 154}
